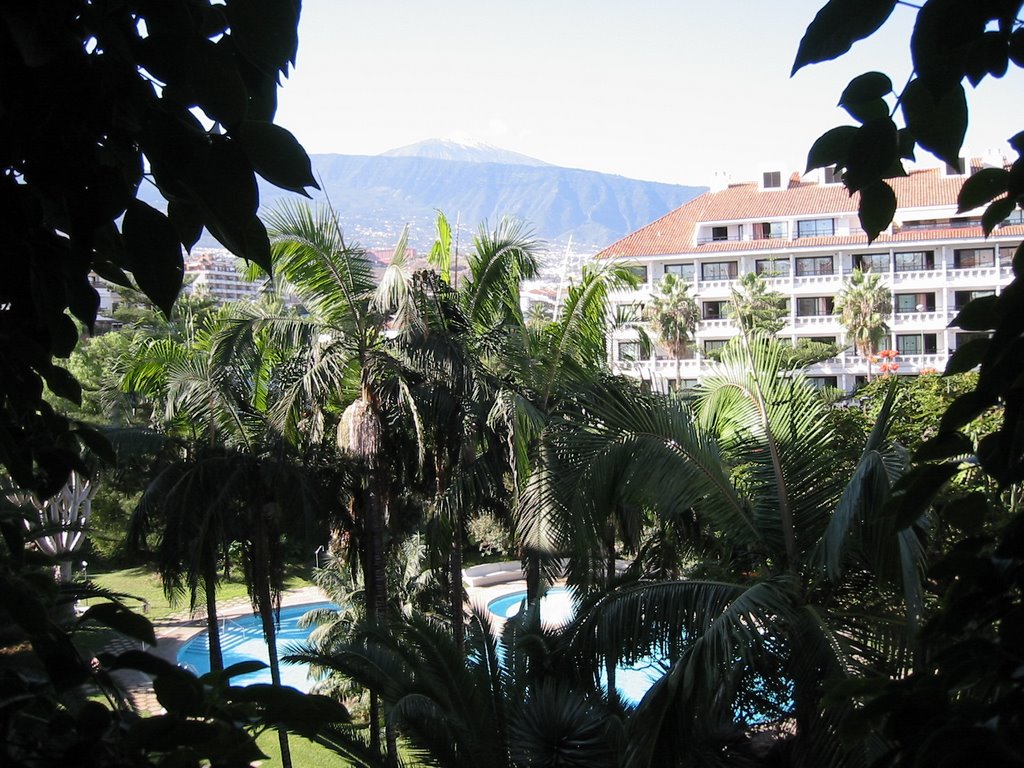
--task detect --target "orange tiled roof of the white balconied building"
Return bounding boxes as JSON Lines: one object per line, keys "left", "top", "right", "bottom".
{"left": 596, "top": 168, "right": 991, "bottom": 258}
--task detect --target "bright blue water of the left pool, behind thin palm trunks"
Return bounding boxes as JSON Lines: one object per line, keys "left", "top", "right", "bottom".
{"left": 178, "top": 603, "right": 335, "bottom": 692}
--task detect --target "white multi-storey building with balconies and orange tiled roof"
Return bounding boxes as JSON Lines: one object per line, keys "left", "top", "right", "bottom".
{"left": 595, "top": 161, "right": 1024, "bottom": 391}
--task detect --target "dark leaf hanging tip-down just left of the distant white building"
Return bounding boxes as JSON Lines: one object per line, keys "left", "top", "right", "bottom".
{"left": 122, "top": 200, "right": 184, "bottom": 316}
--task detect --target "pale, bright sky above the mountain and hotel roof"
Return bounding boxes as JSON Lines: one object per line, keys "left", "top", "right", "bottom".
{"left": 276, "top": 0, "right": 1024, "bottom": 185}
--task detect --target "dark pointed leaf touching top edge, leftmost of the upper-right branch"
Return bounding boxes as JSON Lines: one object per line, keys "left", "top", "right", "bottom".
{"left": 791, "top": 0, "right": 896, "bottom": 75}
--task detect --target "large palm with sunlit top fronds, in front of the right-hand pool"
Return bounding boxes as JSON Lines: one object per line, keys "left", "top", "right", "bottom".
{"left": 536, "top": 338, "right": 923, "bottom": 766}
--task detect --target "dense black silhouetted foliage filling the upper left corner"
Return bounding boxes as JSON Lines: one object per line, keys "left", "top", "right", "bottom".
{"left": 0, "top": 0, "right": 315, "bottom": 496}
